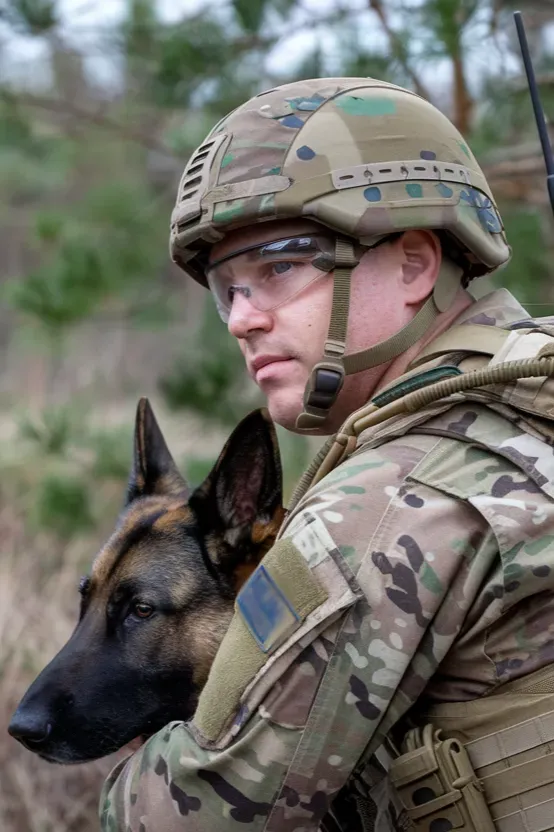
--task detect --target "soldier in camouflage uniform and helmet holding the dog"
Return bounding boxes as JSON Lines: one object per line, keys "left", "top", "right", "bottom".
{"left": 101, "top": 78, "right": 554, "bottom": 832}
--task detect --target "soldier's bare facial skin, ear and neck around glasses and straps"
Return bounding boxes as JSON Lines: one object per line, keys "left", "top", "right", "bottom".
{"left": 210, "top": 220, "right": 413, "bottom": 433}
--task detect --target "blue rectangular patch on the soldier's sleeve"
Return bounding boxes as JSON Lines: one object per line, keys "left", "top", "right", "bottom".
{"left": 237, "top": 566, "right": 300, "bottom": 653}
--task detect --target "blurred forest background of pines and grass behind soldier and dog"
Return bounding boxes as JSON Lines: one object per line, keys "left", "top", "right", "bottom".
{"left": 0, "top": 0, "right": 554, "bottom": 832}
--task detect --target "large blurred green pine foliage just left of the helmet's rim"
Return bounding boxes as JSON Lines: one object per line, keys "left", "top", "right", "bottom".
{"left": 5, "top": 181, "right": 164, "bottom": 332}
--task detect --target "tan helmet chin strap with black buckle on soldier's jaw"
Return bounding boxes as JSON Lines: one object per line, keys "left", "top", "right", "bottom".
{"left": 296, "top": 245, "right": 463, "bottom": 431}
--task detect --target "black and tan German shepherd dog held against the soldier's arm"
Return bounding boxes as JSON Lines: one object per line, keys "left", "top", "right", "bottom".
{"left": 8, "top": 399, "right": 284, "bottom": 763}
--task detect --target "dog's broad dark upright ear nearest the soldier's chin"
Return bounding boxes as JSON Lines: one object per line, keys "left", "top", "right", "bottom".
{"left": 189, "top": 408, "right": 284, "bottom": 578}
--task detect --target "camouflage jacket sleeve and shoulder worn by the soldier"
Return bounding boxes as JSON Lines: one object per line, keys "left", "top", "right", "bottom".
{"left": 101, "top": 290, "right": 554, "bottom": 832}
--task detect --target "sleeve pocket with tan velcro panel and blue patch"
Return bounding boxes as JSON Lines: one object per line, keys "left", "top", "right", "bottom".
{"left": 191, "top": 520, "right": 362, "bottom": 749}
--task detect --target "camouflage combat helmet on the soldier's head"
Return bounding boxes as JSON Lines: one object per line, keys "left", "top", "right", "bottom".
{"left": 170, "top": 78, "right": 510, "bottom": 427}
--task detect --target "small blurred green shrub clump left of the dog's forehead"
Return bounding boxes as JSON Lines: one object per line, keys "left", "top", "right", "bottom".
{"left": 31, "top": 474, "right": 94, "bottom": 540}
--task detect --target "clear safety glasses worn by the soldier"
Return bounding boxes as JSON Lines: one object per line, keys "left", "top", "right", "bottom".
{"left": 206, "top": 235, "right": 335, "bottom": 323}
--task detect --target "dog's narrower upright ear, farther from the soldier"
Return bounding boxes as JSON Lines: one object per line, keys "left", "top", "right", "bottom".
{"left": 127, "top": 399, "right": 189, "bottom": 504}
